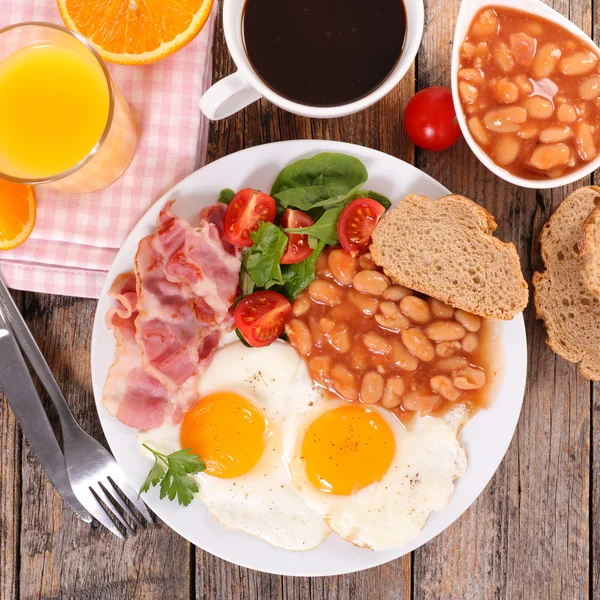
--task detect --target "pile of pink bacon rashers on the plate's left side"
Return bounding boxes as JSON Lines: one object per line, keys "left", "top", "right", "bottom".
{"left": 103, "top": 202, "right": 241, "bottom": 429}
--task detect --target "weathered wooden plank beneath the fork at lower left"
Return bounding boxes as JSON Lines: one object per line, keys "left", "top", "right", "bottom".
{"left": 13, "top": 293, "right": 190, "bottom": 600}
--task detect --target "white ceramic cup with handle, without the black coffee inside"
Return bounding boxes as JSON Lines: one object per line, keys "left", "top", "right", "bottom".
{"left": 200, "top": 0, "right": 424, "bottom": 121}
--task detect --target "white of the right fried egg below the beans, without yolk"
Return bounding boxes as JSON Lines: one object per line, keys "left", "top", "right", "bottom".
{"left": 284, "top": 380, "right": 467, "bottom": 550}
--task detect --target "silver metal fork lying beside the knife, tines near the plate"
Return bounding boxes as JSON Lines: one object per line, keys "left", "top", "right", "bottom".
{"left": 0, "top": 278, "right": 154, "bottom": 539}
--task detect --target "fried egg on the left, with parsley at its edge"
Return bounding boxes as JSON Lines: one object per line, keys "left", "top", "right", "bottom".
{"left": 139, "top": 341, "right": 329, "bottom": 551}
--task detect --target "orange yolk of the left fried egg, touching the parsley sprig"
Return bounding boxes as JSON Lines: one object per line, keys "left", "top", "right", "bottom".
{"left": 179, "top": 392, "right": 266, "bottom": 478}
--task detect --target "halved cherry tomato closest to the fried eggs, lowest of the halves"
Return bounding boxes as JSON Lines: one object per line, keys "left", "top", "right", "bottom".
{"left": 233, "top": 290, "right": 292, "bottom": 348}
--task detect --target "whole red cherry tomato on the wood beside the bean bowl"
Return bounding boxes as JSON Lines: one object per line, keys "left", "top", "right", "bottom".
{"left": 404, "top": 86, "right": 460, "bottom": 150}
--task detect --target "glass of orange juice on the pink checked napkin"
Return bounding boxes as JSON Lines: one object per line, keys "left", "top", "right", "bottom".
{"left": 0, "top": 23, "right": 137, "bottom": 193}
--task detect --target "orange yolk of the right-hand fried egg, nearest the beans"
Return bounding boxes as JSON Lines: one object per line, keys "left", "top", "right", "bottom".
{"left": 302, "top": 405, "right": 396, "bottom": 495}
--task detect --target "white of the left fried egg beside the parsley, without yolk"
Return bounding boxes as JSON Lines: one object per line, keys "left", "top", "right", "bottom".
{"left": 138, "top": 341, "right": 330, "bottom": 551}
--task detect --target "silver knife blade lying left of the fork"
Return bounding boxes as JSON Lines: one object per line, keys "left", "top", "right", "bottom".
{"left": 0, "top": 311, "right": 92, "bottom": 523}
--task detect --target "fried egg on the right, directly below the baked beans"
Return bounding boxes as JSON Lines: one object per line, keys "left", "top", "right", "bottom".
{"left": 284, "top": 380, "right": 467, "bottom": 550}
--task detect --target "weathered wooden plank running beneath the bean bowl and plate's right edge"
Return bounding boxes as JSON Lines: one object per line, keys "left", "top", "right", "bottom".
{"left": 414, "top": 0, "right": 591, "bottom": 599}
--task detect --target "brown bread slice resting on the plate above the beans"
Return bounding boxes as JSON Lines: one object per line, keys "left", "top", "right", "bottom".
{"left": 371, "top": 195, "right": 529, "bottom": 319}
